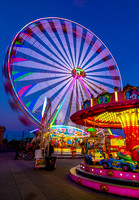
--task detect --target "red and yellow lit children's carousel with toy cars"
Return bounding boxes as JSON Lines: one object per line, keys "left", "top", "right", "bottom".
{"left": 70, "top": 84, "right": 139, "bottom": 198}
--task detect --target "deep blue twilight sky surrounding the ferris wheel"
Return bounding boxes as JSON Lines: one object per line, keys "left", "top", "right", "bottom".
{"left": 0, "top": 0, "right": 139, "bottom": 139}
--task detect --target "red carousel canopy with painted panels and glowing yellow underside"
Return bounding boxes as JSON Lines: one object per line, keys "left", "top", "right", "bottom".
{"left": 71, "top": 84, "right": 139, "bottom": 129}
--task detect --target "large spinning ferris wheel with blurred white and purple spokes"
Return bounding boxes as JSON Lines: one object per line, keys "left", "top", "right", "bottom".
{"left": 5, "top": 17, "right": 122, "bottom": 126}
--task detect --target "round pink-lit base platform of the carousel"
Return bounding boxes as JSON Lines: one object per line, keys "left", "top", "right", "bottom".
{"left": 70, "top": 162, "right": 139, "bottom": 198}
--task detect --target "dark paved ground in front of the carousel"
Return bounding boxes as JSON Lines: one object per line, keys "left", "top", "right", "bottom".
{"left": 0, "top": 152, "right": 131, "bottom": 200}
